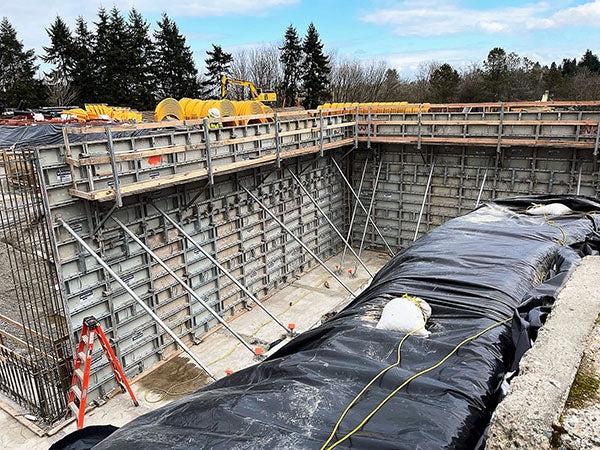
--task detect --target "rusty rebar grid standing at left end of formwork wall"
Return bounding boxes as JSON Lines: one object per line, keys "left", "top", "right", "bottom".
{"left": 0, "top": 149, "right": 71, "bottom": 423}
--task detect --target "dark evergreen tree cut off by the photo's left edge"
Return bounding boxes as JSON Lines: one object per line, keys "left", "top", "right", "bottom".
{"left": 0, "top": 17, "right": 45, "bottom": 109}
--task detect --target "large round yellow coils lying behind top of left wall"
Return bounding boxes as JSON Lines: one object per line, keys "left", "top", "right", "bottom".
{"left": 154, "top": 98, "right": 273, "bottom": 125}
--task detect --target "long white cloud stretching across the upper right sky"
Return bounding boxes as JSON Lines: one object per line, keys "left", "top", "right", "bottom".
{"left": 362, "top": 0, "right": 600, "bottom": 36}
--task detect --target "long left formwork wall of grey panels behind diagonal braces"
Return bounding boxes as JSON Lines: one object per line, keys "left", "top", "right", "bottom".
{"left": 47, "top": 157, "right": 344, "bottom": 398}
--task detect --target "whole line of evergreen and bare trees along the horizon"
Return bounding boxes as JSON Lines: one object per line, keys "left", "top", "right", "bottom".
{"left": 0, "top": 7, "right": 600, "bottom": 110}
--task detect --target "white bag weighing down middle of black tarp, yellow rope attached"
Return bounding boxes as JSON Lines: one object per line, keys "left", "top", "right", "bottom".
{"left": 375, "top": 295, "right": 431, "bottom": 337}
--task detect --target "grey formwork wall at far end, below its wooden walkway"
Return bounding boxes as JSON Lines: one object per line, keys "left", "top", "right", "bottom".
{"left": 351, "top": 144, "right": 600, "bottom": 247}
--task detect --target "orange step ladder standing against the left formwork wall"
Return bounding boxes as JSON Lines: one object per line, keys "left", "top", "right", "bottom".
{"left": 67, "top": 316, "right": 139, "bottom": 429}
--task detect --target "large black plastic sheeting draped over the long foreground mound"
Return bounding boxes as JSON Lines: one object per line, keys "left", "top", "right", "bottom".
{"left": 86, "top": 196, "right": 600, "bottom": 450}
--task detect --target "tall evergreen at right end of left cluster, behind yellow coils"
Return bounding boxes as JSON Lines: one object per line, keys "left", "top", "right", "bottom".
{"left": 154, "top": 14, "right": 199, "bottom": 99}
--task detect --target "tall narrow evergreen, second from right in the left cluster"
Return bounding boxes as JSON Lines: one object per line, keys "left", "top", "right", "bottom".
{"left": 125, "top": 8, "right": 155, "bottom": 110}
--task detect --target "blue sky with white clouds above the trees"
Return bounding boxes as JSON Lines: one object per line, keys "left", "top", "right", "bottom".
{"left": 0, "top": 0, "right": 600, "bottom": 77}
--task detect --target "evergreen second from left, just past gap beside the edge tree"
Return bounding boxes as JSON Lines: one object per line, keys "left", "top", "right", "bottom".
{"left": 42, "top": 16, "right": 77, "bottom": 106}
